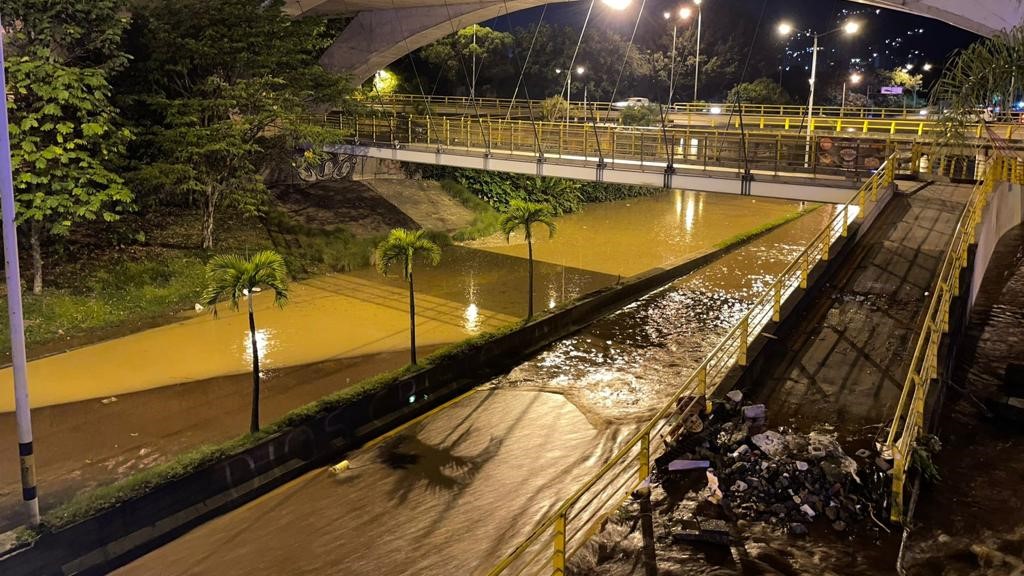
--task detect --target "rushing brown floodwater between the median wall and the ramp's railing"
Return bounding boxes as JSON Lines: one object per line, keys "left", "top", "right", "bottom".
{"left": 116, "top": 203, "right": 830, "bottom": 576}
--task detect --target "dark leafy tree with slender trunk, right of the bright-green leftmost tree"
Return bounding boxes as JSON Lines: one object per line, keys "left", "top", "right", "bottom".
{"left": 124, "top": 0, "right": 348, "bottom": 249}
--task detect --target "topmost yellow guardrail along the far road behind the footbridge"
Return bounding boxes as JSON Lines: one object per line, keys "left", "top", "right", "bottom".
{"left": 366, "top": 94, "right": 1022, "bottom": 123}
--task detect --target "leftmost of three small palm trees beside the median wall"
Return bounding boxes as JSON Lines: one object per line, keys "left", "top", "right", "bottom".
{"left": 203, "top": 250, "right": 288, "bottom": 433}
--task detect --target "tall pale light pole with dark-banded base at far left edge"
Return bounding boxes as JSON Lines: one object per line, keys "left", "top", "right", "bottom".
{"left": 0, "top": 15, "right": 39, "bottom": 526}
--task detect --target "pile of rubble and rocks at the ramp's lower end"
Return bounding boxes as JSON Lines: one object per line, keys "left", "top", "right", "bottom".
{"left": 657, "top": 392, "right": 888, "bottom": 536}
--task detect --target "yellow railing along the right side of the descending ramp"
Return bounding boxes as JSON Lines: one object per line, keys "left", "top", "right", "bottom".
{"left": 886, "top": 151, "right": 1024, "bottom": 522}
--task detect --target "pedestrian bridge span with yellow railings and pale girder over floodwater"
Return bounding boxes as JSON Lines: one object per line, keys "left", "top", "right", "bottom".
{"left": 319, "top": 116, "right": 958, "bottom": 203}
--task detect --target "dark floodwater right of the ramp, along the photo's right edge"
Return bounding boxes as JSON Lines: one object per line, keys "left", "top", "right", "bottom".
{"left": 905, "top": 225, "right": 1024, "bottom": 576}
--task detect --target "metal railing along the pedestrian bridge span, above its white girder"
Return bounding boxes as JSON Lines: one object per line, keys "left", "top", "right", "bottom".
{"left": 324, "top": 114, "right": 915, "bottom": 180}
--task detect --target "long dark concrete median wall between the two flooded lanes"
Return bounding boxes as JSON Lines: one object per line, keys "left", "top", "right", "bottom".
{"left": 0, "top": 213, "right": 794, "bottom": 576}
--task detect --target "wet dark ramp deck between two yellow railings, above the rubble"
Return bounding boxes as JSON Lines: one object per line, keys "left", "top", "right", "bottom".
{"left": 757, "top": 184, "right": 972, "bottom": 436}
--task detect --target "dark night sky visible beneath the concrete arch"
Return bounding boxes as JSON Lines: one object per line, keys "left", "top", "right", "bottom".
{"left": 484, "top": 0, "right": 978, "bottom": 75}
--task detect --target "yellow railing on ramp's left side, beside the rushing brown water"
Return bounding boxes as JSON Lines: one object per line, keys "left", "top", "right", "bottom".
{"left": 488, "top": 155, "right": 898, "bottom": 576}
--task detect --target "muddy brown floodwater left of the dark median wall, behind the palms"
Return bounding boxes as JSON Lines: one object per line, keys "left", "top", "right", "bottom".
{"left": 0, "top": 192, "right": 799, "bottom": 531}
